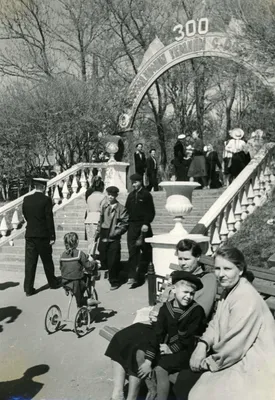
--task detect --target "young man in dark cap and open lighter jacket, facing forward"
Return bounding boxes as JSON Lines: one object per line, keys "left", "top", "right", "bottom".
{"left": 95, "top": 186, "right": 129, "bottom": 290}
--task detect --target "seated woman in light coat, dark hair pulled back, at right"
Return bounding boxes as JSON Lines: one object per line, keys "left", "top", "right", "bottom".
{"left": 174, "top": 247, "right": 275, "bottom": 400}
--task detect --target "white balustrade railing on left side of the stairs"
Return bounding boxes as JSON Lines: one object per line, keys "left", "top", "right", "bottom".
{"left": 0, "top": 163, "right": 112, "bottom": 246}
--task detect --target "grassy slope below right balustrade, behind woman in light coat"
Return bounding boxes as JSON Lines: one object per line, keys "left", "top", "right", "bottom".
{"left": 226, "top": 190, "right": 275, "bottom": 268}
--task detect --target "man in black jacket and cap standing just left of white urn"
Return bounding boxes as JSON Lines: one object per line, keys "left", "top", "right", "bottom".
{"left": 125, "top": 174, "right": 155, "bottom": 289}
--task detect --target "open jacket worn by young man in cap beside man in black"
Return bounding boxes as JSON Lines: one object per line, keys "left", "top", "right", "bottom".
{"left": 95, "top": 202, "right": 129, "bottom": 241}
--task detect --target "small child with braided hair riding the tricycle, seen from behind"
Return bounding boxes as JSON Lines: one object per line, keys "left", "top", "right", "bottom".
{"left": 60, "top": 232, "right": 100, "bottom": 307}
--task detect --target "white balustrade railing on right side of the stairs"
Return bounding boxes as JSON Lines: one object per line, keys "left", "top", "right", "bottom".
{"left": 190, "top": 143, "right": 275, "bottom": 254}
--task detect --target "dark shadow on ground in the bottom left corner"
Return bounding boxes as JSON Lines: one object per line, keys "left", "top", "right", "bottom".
{"left": 0, "top": 364, "right": 50, "bottom": 400}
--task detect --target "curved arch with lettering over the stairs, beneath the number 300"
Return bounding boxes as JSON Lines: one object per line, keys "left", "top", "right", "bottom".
{"left": 119, "top": 29, "right": 275, "bottom": 132}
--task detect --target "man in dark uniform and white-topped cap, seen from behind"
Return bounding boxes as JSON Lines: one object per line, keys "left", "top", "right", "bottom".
{"left": 22, "top": 178, "right": 58, "bottom": 296}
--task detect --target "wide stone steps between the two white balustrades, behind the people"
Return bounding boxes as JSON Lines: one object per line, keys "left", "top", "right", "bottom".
{"left": 0, "top": 189, "right": 223, "bottom": 274}
